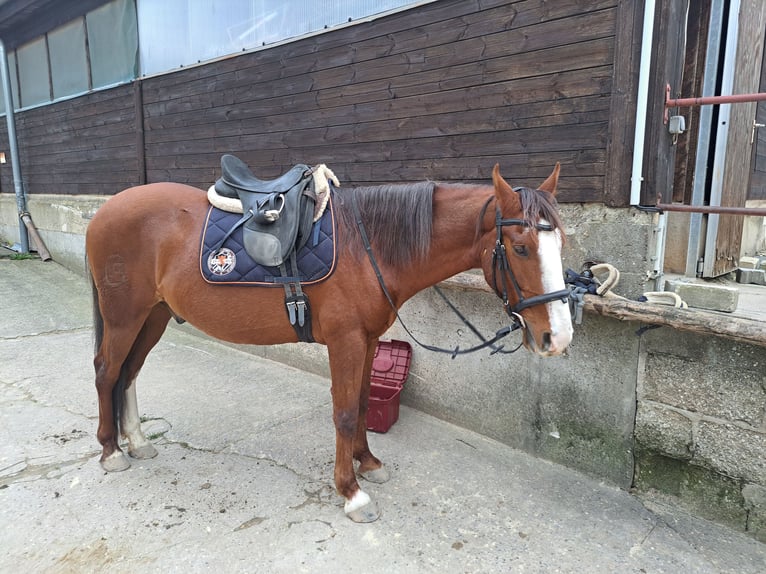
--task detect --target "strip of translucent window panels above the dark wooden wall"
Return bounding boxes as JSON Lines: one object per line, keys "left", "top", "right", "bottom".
{"left": 0, "top": 0, "right": 420, "bottom": 112}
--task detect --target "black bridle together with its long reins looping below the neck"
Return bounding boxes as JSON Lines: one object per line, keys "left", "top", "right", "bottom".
{"left": 351, "top": 188, "right": 570, "bottom": 359}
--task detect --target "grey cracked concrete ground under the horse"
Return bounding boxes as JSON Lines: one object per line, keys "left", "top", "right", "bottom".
{"left": 0, "top": 259, "right": 766, "bottom": 574}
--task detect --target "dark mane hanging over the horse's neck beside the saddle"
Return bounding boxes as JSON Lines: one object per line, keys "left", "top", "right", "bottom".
{"left": 334, "top": 181, "right": 435, "bottom": 265}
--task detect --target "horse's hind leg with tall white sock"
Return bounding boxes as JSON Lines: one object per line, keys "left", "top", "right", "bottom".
{"left": 120, "top": 304, "right": 170, "bottom": 459}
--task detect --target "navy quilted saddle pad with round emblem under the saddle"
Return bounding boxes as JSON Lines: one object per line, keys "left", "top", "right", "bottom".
{"left": 199, "top": 200, "right": 336, "bottom": 287}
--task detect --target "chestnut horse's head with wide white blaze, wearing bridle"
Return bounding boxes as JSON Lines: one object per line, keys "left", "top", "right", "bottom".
{"left": 481, "top": 164, "right": 572, "bottom": 356}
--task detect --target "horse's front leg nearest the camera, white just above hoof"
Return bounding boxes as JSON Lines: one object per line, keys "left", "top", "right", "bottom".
{"left": 327, "top": 333, "right": 379, "bottom": 522}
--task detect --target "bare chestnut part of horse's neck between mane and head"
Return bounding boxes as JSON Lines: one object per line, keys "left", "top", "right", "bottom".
{"left": 401, "top": 186, "right": 493, "bottom": 298}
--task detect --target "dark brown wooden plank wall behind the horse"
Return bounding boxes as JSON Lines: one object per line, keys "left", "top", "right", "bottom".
{"left": 0, "top": 0, "right": 643, "bottom": 205}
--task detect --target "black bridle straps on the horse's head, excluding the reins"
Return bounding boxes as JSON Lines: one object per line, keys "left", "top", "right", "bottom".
{"left": 488, "top": 194, "right": 570, "bottom": 330}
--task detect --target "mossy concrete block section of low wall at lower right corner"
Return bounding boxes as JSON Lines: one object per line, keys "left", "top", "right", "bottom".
{"left": 635, "top": 329, "right": 766, "bottom": 541}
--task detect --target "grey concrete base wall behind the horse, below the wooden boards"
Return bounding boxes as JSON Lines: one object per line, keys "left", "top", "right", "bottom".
{"left": 0, "top": 194, "right": 766, "bottom": 539}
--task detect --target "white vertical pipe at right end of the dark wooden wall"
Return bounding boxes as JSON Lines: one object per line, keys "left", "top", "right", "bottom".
{"left": 630, "top": 0, "right": 655, "bottom": 209}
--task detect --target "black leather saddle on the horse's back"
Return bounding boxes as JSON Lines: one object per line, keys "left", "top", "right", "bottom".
{"left": 214, "top": 154, "right": 316, "bottom": 267}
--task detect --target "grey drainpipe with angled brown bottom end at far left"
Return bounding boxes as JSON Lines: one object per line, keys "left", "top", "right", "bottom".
{"left": 0, "top": 39, "right": 51, "bottom": 261}
